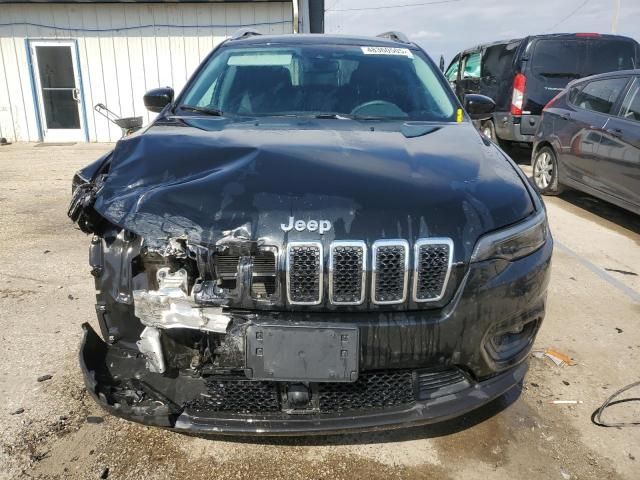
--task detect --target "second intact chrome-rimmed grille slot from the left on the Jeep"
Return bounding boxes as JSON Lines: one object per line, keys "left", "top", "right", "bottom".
{"left": 329, "top": 241, "right": 367, "bottom": 305}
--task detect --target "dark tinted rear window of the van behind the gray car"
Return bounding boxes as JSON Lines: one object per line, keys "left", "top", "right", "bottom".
{"left": 531, "top": 38, "right": 636, "bottom": 79}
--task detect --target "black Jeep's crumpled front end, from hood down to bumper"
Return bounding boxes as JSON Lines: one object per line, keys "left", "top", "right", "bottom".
{"left": 69, "top": 119, "right": 552, "bottom": 435}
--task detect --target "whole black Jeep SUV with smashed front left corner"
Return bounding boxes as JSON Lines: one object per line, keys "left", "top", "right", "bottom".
{"left": 69, "top": 32, "right": 552, "bottom": 435}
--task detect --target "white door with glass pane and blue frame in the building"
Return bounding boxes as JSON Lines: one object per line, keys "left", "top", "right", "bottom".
{"left": 29, "top": 40, "right": 85, "bottom": 142}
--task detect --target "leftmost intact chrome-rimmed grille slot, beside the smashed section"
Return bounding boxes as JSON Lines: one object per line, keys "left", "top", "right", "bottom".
{"left": 287, "top": 242, "right": 324, "bottom": 305}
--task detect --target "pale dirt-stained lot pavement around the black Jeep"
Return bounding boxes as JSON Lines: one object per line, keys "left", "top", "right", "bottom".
{"left": 0, "top": 145, "right": 640, "bottom": 480}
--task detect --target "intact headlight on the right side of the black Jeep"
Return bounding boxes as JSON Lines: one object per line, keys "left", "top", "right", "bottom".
{"left": 471, "top": 210, "right": 549, "bottom": 262}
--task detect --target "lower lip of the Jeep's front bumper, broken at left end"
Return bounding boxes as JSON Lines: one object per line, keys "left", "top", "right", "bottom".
{"left": 80, "top": 323, "right": 528, "bottom": 435}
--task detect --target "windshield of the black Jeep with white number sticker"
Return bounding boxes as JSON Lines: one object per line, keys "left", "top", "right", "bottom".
{"left": 179, "top": 45, "right": 456, "bottom": 121}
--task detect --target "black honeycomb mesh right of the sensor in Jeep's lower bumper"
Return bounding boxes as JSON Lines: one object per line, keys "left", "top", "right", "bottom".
{"left": 318, "top": 370, "right": 415, "bottom": 412}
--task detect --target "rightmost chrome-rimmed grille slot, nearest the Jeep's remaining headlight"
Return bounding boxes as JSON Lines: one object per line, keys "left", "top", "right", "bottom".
{"left": 413, "top": 238, "right": 453, "bottom": 302}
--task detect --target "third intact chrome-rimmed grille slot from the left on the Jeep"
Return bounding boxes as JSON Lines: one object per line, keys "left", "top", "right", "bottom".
{"left": 371, "top": 240, "right": 409, "bottom": 305}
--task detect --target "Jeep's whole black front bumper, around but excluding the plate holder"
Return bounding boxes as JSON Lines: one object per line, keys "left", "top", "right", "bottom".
{"left": 80, "top": 239, "right": 553, "bottom": 435}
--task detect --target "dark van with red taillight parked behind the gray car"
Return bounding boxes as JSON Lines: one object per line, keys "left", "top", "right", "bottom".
{"left": 445, "top": 33, "right": 640, "bottom": 144}
